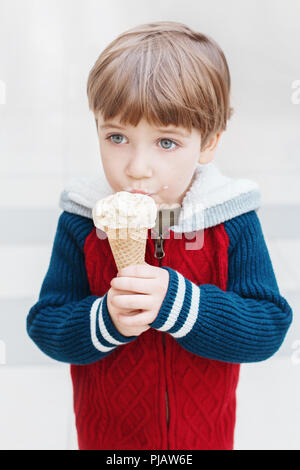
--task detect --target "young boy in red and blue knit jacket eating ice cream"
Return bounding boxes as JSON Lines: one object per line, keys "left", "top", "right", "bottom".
{"left": 27, "top": 21, "right": 292, "bottom": 450}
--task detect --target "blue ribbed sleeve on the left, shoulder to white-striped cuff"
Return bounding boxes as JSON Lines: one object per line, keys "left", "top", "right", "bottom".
{"left": 27, "top": 212, "right": 136, "bottom": 364}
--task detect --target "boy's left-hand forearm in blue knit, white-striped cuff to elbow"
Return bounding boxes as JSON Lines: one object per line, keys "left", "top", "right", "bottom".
{"left": 27, "top": 294, "right": 133, "bottom": 364}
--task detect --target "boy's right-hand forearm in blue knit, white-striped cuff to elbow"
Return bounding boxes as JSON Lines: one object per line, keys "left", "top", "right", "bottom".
{"left": 150, "top": 267, "right": 291, "bottom": 363}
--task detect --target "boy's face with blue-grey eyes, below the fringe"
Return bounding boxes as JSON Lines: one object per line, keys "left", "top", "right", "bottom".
{"left": 96, "top": 113, "right": 218, "bottom": 208}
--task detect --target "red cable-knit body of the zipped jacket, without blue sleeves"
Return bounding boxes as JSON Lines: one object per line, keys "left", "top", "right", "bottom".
{"left": 71, "top": 224, "right": 239, "bottom": 450}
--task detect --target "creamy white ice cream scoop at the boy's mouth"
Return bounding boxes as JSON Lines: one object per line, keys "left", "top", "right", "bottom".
{"left": 93, "top": 191, "right": 157, "bottom": 230}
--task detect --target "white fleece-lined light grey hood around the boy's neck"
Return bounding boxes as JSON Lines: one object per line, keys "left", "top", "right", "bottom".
{"left": 59, "top": 162, "right": 261, "bottom": 233}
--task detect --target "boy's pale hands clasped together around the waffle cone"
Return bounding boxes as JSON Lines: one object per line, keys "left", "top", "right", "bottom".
{"left": 107, "top": 264, "right": 169, "bottom": 336}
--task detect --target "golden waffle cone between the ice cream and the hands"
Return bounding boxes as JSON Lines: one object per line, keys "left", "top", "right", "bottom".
{"left": 104, "top": 227, "right": 148, "bottom": 271}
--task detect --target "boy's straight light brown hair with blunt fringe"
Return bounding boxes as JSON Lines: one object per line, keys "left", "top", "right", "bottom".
{"left": 87, "top": 21, "right": 233, "bottom": 149}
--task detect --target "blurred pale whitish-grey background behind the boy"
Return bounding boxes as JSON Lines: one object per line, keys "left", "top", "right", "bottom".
{"left": 0, "top": 0, "right": 300, "bottom": 449}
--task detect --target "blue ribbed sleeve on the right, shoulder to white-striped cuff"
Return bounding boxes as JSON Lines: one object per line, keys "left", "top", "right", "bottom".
{"left": 150, "top": 211, "right": 292, "bottom": 363}
